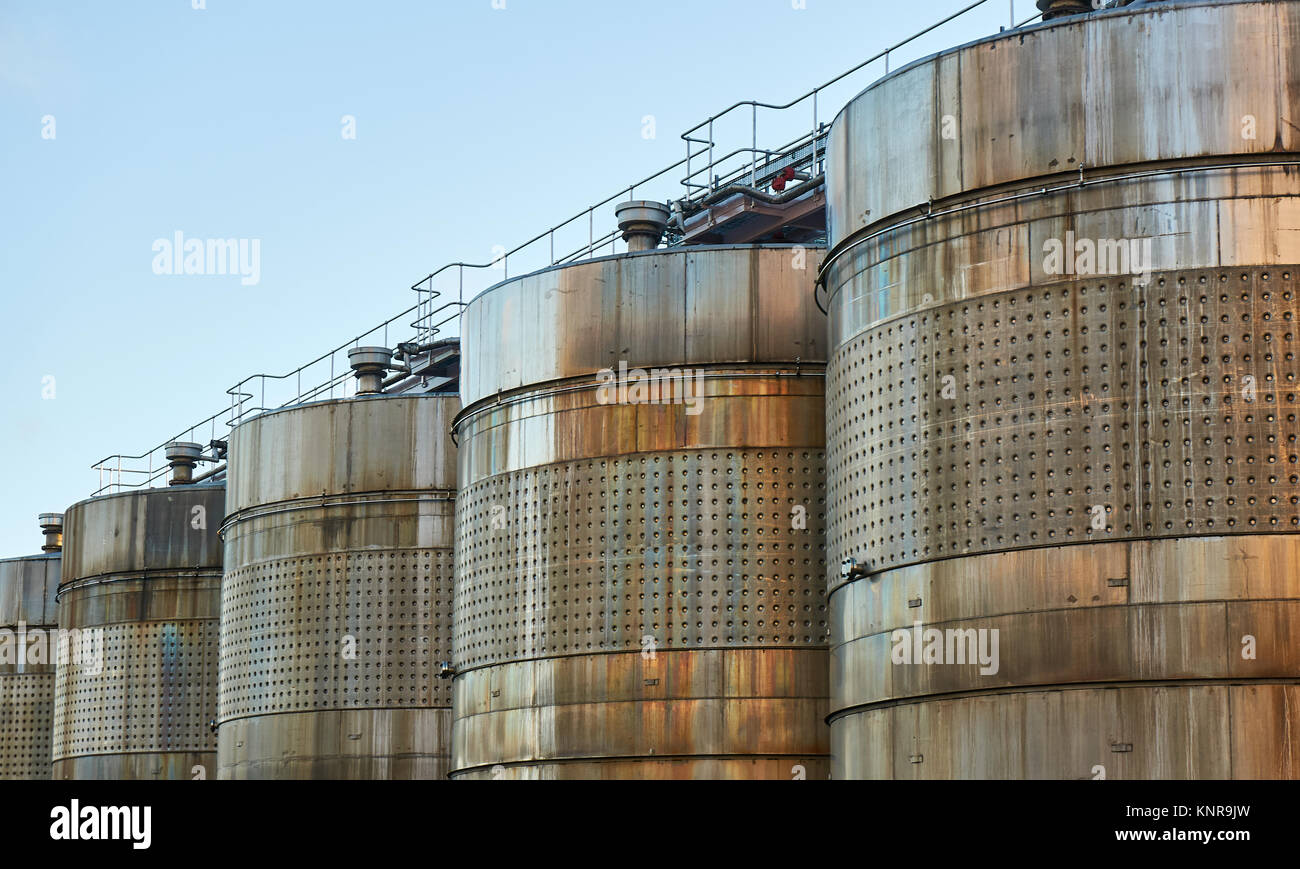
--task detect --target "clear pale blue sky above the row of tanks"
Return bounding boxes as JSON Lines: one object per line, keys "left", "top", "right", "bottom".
{"left": 0, "top": 0, "right": 1035, "bottom": 558}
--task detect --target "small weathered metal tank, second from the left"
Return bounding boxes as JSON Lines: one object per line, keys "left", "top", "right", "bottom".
{"left": 53, "top": 484, "right": 225, "bottom": 779}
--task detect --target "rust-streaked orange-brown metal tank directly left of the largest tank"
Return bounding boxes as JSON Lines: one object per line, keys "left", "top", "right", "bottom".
{"left": 452, "top": 246, "right": 828, "bottom": 778}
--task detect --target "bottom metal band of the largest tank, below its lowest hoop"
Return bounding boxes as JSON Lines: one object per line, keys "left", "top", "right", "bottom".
{"left": 831, "top": 684, "right": 1300, "bottom": 779}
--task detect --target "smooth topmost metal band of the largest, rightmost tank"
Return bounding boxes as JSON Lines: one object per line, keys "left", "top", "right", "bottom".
{"left": 827, "top": 0, "right": 1300, "bottom": 246}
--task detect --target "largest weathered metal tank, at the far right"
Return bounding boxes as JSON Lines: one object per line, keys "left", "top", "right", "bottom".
{"left": 823, "top": 1, "right": 1300, "bottom": 779}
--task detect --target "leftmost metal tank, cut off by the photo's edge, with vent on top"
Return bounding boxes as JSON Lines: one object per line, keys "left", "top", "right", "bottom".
{"left": 0, "top": 513, "right": 64, "bottom": 781}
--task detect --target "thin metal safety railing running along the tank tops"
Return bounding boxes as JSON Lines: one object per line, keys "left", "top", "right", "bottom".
{"left": 92, "top": 0, "right": 1041, "bottom": 494}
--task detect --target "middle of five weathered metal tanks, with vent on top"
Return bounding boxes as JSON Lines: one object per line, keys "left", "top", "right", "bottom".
{"left": 218, "top": 392, "right": 460, "bottom": 779}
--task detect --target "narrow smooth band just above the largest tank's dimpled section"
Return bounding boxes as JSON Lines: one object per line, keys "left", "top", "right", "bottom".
{"left": 827, "top": 167, "right": 1300, "bottom": 347}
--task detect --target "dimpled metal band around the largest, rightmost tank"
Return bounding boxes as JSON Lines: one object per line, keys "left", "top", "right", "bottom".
{"left": 828, "top": 269, "right": 1300, "bottom": 570}
